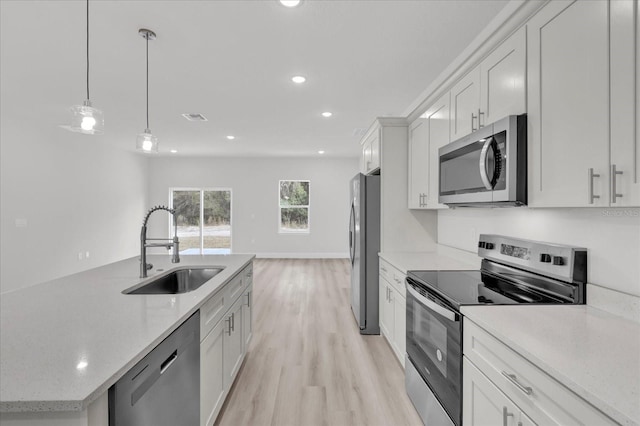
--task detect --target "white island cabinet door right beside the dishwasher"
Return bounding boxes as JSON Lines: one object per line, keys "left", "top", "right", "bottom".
{"left": 200, "top": 321, "right": 226, "bottom": 426}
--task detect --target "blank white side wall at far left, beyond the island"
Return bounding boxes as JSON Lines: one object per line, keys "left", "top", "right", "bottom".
{"left": 0, "top": 118, "right": 147, "bottom": 292}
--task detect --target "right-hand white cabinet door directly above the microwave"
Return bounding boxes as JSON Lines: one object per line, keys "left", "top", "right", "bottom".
{"left": 478, "top": 27, "right": 527, "bottom": 127}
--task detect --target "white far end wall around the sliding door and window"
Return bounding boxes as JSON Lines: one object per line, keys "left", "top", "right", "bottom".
{"left": 148, "top": 157, "right": 358, "bottom": 257}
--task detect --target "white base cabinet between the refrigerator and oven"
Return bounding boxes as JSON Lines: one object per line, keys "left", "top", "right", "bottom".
{"left": 379, "top": 259, "right": 407, "bottom": 367}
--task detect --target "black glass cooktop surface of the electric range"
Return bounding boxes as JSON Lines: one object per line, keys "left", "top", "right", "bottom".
{"left": 408, "top": 270, "right": 563, "bottom": 309}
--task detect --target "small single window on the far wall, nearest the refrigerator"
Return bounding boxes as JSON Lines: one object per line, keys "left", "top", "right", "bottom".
{"left": 279, "top": 180, "right": 310, "bottom": 234}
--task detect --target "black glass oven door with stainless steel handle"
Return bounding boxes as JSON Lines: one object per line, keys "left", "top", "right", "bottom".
{"left": 407, "top": 278, "right": 462, "bottom": 425}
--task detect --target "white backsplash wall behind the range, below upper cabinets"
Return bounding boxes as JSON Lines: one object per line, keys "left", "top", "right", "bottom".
{"left": 438, "top": 208, "right": 640, "bottom": 296}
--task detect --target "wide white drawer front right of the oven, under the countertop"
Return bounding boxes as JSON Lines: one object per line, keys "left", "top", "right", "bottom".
{"left": 463, "top": 320, "right": 615, "bottom": 426}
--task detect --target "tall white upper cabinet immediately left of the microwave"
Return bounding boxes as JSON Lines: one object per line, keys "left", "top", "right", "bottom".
{"left": 408, "top": 92, "right": 450, "bottom": 209}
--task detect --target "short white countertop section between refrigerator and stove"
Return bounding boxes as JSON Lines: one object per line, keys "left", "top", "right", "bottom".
{"left": 379, "top": 245, "right": 482, "bottom": 274}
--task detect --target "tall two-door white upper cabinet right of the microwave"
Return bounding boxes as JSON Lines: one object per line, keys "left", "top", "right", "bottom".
{"left": 527, "top": 0, "right": 640, "bottom": 207}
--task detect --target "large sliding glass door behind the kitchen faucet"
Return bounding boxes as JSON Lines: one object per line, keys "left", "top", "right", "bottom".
{"left": 169, "top": 189, "right": 231, "bottom": 254}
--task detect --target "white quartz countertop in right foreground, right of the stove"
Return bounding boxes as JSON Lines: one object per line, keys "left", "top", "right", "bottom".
{"left": 461, "top": 305, "right": 640, "bottom": 425}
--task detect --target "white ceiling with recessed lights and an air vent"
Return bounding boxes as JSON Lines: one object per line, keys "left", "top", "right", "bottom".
{"left": 0, "top": 0, "right": 507, "bottom": 157}
